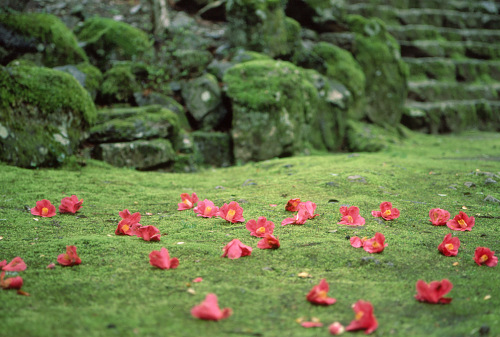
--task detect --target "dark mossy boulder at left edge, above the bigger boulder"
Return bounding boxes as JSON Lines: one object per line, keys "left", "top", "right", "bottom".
{"left": 0, "top": 12, "right": 88, "bottom": 67}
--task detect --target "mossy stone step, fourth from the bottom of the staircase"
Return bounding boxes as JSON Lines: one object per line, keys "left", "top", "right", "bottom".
{"left": 398, "top": 40, "right": 500, "bottom": 60}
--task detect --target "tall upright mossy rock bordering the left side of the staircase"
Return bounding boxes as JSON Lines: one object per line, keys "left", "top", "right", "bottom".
{"left": 347, "top": 15, "right": 408, "bottom": 126}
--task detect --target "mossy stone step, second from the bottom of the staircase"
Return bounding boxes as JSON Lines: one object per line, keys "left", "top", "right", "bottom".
{"left": 407, "top": 81, "right": 500, "bottom": 102}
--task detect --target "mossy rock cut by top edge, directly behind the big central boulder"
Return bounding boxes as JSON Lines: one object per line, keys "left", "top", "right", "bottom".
{"left": 226, "top": 0, "right": 300, "bottom": 57}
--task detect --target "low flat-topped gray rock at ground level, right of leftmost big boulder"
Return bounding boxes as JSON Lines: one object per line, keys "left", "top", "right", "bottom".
{"left": 96, "top": 139, "right": 176, "bottom": 170}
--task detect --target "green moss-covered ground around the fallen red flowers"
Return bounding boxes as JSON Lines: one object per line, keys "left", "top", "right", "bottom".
{"left": 0, "top": 133, "right": 500, "bottom": 337}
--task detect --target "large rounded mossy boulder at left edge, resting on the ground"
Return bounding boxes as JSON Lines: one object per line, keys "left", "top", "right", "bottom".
{"left": 0, "top": 66, "right": 96, "bottom": 167}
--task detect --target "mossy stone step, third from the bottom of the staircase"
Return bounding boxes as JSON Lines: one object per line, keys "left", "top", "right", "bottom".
{"left": 403, "top": 58, "right": 500, "bottom": 82}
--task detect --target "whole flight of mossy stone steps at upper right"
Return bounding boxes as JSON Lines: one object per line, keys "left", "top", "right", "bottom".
{"left": 347, "top": 0, "right": 500, "bottom": 133}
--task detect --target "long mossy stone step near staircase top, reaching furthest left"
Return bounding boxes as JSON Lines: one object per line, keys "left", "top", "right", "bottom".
{"left": 346, "top": 1, "right": 500, "bottom": 29}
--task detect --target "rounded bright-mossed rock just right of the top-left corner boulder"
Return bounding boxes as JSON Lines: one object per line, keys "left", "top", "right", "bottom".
{"left": 76, "top": 17, "right": 152, "bottom": 71}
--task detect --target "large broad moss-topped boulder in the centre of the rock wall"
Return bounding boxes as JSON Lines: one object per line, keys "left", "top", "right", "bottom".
{"left": 224, "top": 60, "right": 346, "bottom": 162}
